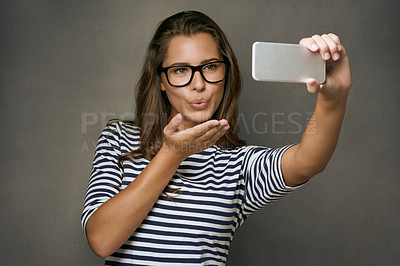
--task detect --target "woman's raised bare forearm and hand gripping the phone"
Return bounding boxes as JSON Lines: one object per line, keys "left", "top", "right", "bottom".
{"left": 282, "top": 33, "right": 352, "bottom": 186}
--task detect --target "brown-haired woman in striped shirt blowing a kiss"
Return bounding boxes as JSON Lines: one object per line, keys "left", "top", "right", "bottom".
{"left": 82, "top": 11, "right": 351, "bottom": 265}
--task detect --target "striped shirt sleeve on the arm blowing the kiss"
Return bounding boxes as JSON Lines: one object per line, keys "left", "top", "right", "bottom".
{"left": 81, "top": 123, "right": 123, "bottom": 233}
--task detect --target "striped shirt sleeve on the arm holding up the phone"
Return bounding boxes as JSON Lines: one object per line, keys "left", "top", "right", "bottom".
{"left": 242, "top": 145, "right": 299, "bottom": 216}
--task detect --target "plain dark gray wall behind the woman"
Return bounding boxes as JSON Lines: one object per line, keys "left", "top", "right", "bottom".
{"left": 0, "top": 0, "right": 400, "bottom": 265}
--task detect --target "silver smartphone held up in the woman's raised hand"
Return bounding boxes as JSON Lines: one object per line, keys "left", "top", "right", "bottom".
{"left": 252, "top": 42, "right": 326, "bottom": 83}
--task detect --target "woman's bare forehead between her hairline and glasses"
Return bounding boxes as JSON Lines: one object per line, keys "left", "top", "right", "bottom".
{"left": 163, "top": 33, "right": 221, "bottom": 66}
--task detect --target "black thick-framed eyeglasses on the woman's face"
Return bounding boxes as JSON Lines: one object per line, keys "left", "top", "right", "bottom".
{"left": 160, "top": 60, "right": 228, "bottom": 87}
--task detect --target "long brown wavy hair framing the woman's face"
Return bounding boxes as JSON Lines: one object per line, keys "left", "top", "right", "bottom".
{"left": 120, "top": 11, "right": 246, "bottom": 162}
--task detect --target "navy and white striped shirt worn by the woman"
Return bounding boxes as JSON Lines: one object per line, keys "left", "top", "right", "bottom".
{"left": 81, "top": 122, "right": 300, "bottom": 265}
